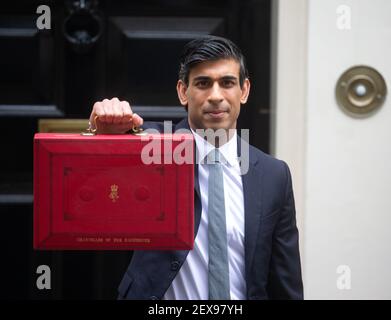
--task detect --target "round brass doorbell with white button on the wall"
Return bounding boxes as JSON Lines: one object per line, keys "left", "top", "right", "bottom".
{"left": 335, "top": 66, "right": 387, "bottom": 116}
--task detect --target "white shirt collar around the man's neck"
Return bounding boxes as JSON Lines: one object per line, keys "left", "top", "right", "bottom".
{"left": 190, "top": 128, "right": 238, "bottom": 166}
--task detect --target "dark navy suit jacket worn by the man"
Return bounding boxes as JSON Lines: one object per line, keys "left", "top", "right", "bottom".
{"left": 118, "top": 119, "right": 303, "bottom": 300}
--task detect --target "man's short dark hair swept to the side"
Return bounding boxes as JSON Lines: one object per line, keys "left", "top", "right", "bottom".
{"left": 178, "top": 35, "right": 248, "bottom": 87}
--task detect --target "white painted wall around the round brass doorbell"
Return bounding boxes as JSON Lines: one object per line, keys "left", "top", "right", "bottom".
{"left": 273, "top": 0, "right": 391, "bottom": 299}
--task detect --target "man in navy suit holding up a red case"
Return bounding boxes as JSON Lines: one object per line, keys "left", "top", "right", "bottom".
{"left": 90, "top": 36, "right": 303, "bottom": 300}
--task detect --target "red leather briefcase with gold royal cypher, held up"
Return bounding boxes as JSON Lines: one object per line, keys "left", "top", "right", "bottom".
{"left": 34, "top": 133, "right": 194, "bottom": 250}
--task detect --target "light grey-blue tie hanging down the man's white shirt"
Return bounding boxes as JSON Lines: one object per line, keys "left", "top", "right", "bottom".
{"left": 208, "top": 149, "right": 230, "bottom": 300}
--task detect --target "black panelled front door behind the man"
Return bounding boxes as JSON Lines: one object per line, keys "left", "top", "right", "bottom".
{"left": 0, "top": 0, "right": 271, "bottom": 299}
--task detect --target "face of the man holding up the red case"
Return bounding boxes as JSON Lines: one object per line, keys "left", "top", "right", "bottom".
{"left": 177, "top": 59, "right": 250, "bottom": 130}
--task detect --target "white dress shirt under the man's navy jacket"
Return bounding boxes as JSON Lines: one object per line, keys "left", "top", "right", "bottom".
{"left": 163, "top": 130, "right": 246, "bottom": 300}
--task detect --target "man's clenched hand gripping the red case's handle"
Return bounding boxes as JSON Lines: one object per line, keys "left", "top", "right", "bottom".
{"left": 90, "top": 98, "right": 144, "bottom": 134}
